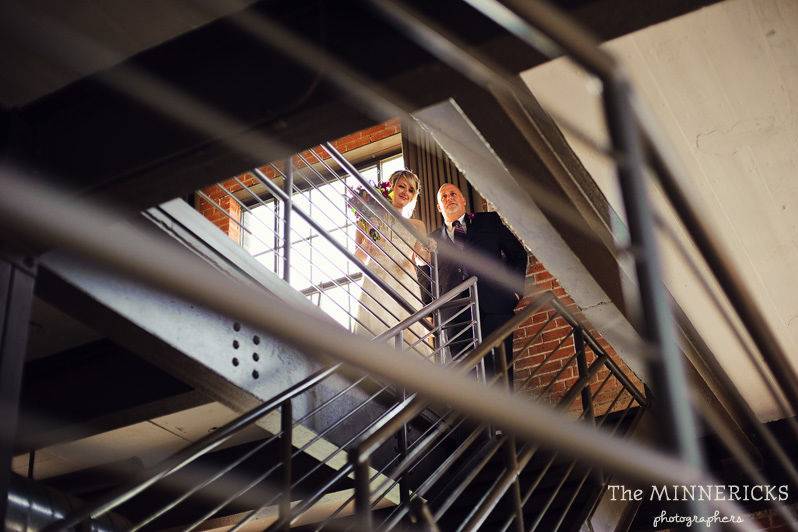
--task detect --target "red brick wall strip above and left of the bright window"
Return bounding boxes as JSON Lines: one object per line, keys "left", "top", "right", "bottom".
{"left": 196, "top": 118, "right": 401, "bottom": 238}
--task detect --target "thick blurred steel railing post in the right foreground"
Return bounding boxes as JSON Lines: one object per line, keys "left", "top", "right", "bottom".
{"left": 604, "top": 74, "right": 704, "bottom": 515}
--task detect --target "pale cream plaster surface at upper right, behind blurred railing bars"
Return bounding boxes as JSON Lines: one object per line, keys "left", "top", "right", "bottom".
{"left": 522, "top": 0, "right": 798, "bottom": 420}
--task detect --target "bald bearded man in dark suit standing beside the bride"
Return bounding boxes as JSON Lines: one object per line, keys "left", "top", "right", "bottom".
{"left": 430, "top": 183, "right": 527, "bottom": 388}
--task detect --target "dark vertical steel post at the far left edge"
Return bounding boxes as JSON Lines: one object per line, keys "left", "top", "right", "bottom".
{"left": 0, "top": 255, "right": 36, "bottom": 523}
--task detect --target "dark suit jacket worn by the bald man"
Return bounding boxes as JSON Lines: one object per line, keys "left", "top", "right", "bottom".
{"left": 430, "top": 212, "right": 527, "bottom": 315}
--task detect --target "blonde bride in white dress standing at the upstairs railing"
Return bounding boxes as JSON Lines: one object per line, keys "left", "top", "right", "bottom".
{"left": 355, "top": 170, "right": 432, "bottom": 356}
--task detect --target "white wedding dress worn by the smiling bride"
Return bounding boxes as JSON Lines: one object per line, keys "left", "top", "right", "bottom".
{"left": 355, "top": 214, "right": 432, "bottom": 357}
